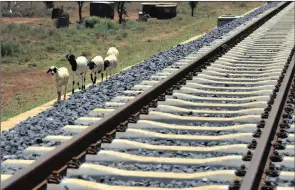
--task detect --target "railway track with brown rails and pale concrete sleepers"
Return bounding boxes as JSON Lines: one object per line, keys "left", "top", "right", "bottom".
{"left": 1, "top": 2, "right": 295, "bottom": 190}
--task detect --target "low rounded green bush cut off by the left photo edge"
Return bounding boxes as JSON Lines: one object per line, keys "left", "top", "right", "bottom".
{"left": 1, "top": 40, "right": 23, "bottom": 57}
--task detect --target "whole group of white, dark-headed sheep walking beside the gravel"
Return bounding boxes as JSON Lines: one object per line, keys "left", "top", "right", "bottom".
{"left": 47, "top": 47, "right": 119, "bottom": 102}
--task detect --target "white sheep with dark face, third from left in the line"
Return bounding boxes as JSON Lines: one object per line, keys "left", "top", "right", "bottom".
{"left": 87, "top": 56, "right": 107, "bottom": 84}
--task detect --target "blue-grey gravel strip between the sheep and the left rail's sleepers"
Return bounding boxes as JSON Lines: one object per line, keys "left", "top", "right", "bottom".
{"left": 1, "top": 2, "right": 278, "bottom": 160}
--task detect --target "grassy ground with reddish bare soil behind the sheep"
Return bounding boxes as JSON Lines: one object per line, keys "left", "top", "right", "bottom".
{"left": 0, "top": 2, "right": 262, "bottom": 120}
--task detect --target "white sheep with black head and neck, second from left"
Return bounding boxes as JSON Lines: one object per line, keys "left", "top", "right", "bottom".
{"left": 66, "top": 54, "right": 88, "bottom": 93}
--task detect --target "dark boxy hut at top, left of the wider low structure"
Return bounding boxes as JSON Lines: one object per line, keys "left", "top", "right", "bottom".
{"left": 90, "top": 1, "right": 115, "bottom": 19}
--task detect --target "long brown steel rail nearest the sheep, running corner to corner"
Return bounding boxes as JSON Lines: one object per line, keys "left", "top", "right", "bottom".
{"left": 1, "top": 2, "right": 291, "bottom": 190}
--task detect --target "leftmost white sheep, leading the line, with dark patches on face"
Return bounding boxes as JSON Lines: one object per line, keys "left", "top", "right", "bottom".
{"left": 47, "top": 66, "right": 70, "bottom": 102}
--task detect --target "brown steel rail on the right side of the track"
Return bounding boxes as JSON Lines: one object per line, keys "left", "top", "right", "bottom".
{"left": 240, "top": 51, "right": 295, "bottom": 190}
